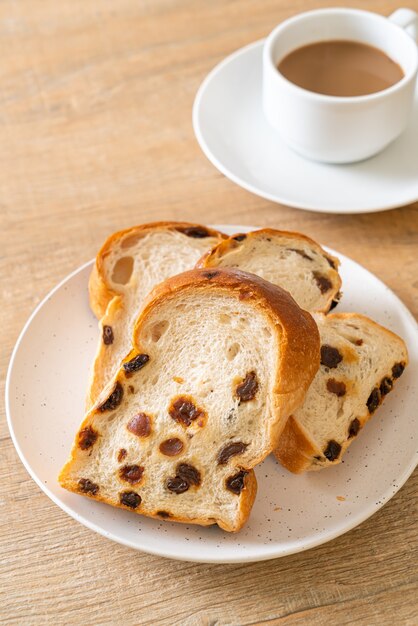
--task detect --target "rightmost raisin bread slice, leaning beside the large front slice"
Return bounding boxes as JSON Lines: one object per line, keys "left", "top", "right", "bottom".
{"left": 275, "top": 313, "right": 408, "bottom": 473}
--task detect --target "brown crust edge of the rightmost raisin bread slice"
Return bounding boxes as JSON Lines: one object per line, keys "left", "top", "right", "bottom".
{"left": 274, "top": 313, "right": 409, "bottom": 474}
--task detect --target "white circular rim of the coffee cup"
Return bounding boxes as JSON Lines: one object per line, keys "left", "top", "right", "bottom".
{"left": 263, "top": 7, "right": 418, "bottom": 104}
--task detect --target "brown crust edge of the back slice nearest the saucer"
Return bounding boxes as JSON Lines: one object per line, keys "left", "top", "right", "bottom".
{"left": 195, "top": 228, "right": 342, "bottom": 313}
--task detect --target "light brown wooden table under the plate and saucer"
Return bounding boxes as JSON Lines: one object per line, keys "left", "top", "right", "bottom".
{"left": 0, "top": 0, "right": 418, "bottom": 626}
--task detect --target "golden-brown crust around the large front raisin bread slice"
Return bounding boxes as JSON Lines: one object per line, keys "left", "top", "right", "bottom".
{"left": 58, "top": 269, "right": 319, "bottom": 532}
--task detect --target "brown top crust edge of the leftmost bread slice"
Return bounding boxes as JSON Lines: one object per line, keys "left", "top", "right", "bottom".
{"left": 89, "top": 222, "right": 227, "bottom": 319}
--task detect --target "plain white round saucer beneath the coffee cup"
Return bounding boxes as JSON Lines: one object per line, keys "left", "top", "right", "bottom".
{"left": 193, "top": 41, "right": 418, "bottom": 213}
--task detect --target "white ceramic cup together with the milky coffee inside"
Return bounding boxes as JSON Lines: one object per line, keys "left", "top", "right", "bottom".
{"left": 262, "top": 8, "right": 418, "bottom": 163}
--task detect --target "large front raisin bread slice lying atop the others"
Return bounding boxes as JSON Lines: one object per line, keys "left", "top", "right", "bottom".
{"left": 59, "top": 270, "right": 319, "bottom": 531}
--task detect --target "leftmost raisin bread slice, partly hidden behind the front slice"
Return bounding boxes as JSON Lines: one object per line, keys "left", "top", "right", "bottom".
{"left": 87, "top": 222, "right": 225, "bottom": 407}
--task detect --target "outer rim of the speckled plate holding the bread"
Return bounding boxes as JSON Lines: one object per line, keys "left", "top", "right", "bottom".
{"left": 5, "top": 224, "right": 418, "bottom": 564}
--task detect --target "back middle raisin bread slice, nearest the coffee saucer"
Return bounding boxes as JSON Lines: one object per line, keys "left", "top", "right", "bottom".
{"left": 197, "top": 228, "right": 341, "bottom": 313}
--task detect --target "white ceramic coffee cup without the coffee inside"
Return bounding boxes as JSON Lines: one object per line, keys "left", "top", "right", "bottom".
{"left": 263, "top": 9, "right": 418, "bottom": 163}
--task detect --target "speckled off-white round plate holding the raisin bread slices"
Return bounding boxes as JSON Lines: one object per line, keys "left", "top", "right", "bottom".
{"left": 6, "top": 226, "right": 418, "bottom": 563}
